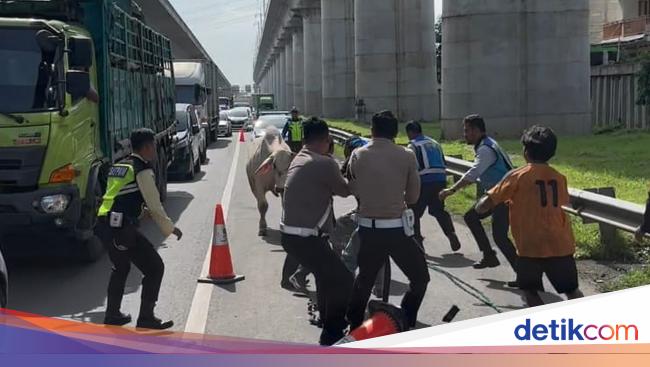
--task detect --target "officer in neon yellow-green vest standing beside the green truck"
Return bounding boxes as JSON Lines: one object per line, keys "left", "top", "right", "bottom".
{"left": 99, "top": 129, "right": 183, "bottom": 330}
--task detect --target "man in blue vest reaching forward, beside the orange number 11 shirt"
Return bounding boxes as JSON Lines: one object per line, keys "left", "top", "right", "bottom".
{"left": 440, "top": 115, "right": 518, "bottom": 287}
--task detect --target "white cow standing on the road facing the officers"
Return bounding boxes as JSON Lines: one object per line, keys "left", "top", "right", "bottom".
{"left": 246, "top": 127, "right": 294, "bottom": 236}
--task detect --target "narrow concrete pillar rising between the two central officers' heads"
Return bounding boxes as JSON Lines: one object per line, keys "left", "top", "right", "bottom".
{"left": 321, "top": 0, "right": 355, "bottom": 118}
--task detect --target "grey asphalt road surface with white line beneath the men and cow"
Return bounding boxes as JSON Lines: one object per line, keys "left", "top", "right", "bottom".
{"left": 2, "top": 138, "right": 594, "bottom": 343}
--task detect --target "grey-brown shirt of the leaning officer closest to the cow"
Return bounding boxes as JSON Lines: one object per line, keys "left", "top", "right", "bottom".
{"left": 282, "top": 148, "right": 350, "bottom": 233}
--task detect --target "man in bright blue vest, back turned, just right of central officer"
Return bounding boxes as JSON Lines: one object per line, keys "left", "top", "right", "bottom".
{"left": 406, "top": 121, "right": 460, "bottom": 251}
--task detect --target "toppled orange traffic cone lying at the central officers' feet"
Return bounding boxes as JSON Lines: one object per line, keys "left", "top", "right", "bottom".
{"left": 336, "top": 300, "right": 406, "bottom": 345}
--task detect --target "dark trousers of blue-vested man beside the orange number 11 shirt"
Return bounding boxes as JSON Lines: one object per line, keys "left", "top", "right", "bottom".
{"left": 464, "top": 204, "right": 518, "bottom": 272}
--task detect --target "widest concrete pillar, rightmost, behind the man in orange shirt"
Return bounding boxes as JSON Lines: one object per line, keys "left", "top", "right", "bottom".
{"left": 442, "top": 0, "right": 591, "bottom": 138}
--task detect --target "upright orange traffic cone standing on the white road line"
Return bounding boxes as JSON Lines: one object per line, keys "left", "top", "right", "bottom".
{"left": 198, "top": 204, "right": 244, "bottom": 284}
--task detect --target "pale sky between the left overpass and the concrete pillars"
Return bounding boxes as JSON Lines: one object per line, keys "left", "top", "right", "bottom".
{"left": 170, "top": 0, "right": 442, "bottom": 86}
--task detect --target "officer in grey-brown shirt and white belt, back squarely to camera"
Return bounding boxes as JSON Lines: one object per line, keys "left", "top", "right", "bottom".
{"left": 347, "top": 111, "right": 429, "bottom": 329}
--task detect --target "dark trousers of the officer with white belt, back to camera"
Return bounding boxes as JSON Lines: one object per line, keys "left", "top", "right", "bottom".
{"left": 347, "top": 227, "right": 430, "bottom": 329}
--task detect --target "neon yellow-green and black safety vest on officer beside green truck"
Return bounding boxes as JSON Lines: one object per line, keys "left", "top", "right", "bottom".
{"left": 98, "top": 156, "right": 151, "bottom": 220}
